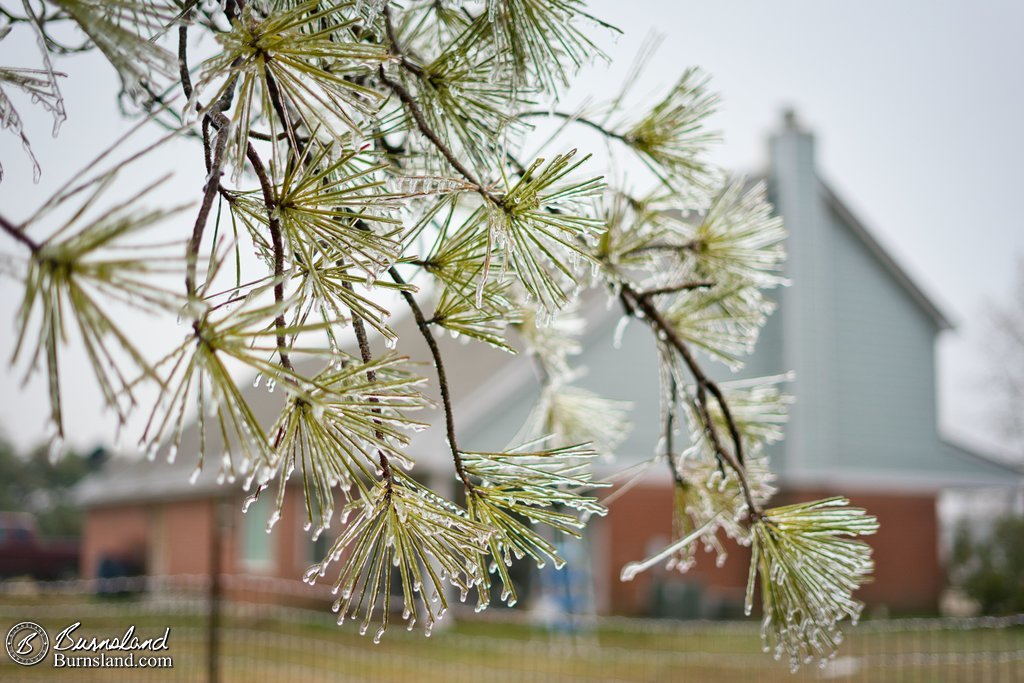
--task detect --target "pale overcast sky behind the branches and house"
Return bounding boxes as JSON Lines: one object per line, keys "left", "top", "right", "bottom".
{"left": 0, "top": 0, "right": 1024, "bottom": 458}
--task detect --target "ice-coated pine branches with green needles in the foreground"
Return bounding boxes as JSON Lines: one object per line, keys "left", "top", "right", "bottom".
{"left": 0, "top": 0, "right": 876, "bottom": 666}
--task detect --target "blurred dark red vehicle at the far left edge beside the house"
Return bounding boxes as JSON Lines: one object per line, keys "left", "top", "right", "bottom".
{"left": 0, "top": 512, "right": 80, "bottom": 581}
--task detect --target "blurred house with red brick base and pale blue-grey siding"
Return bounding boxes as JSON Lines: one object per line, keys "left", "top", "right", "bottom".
{"left": 78, "top": 111, "right": 1021, "bottom": 616}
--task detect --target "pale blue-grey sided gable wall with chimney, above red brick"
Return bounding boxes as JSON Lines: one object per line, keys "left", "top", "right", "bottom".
{"left": 770, "top": 120, "right": 1019, "bottom": 490}
